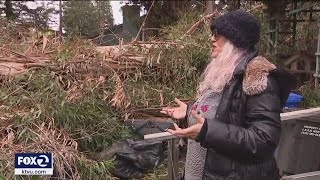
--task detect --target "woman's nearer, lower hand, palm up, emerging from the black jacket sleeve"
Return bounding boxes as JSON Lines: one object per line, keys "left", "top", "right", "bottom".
{"left": 167, "top": 111, "right": 205, "bottom": 140}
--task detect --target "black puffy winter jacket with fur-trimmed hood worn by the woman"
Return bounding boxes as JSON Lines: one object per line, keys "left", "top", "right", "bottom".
{"left": 188, "top": 51, "right": 295, "bottom": 180}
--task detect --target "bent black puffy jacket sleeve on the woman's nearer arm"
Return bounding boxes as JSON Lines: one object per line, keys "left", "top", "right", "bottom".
{"left": 197, "top": 78, "right": 282, "bottom": 159}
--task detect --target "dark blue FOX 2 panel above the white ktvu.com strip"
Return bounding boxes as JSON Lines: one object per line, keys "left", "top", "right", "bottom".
{"left": 14, "top": 153, "right": 53, "bottom": 168}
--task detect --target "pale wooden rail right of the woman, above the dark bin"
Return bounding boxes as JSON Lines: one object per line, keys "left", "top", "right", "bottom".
{"left": 280, "top": 107, "right": 320, "bottom": 121}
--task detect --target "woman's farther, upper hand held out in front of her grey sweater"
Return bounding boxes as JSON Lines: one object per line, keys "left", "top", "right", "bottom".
{"left": 160, "top": 98, "right": 187, "bottom": 119}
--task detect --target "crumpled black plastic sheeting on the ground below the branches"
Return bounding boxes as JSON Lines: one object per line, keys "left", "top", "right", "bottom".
{"left": 97, "top": 139, "right": 165, "bottom": 179}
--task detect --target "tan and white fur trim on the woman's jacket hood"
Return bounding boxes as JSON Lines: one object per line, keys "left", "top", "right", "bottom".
{"left": 243, "top": 56, "right": 277, "bottom": 95}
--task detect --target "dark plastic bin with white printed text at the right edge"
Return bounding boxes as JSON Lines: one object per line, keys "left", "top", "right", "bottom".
{"left": 276, "top": 115, "right": 320, "bottom": 175}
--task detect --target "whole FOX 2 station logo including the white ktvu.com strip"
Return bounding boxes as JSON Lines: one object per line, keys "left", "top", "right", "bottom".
{"left": 14, "top": 153, "right": 53, "bottom": 175}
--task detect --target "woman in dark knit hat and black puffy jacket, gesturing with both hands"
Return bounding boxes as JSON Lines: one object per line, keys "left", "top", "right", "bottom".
{"left": 161, "top": 10, "right": 295, "bottom": 180}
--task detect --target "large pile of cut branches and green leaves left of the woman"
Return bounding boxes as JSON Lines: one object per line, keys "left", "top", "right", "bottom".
{"left": 0, "top": 10, "right": 215, "bottom": 179}
